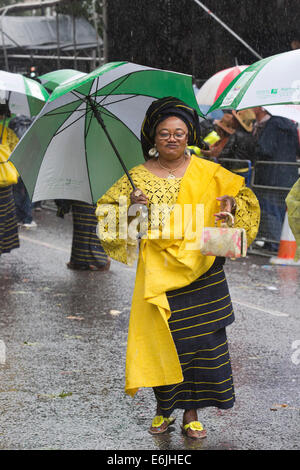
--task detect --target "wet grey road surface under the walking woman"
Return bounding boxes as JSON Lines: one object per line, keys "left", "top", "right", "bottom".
{"left": 0, "top": 206, "right": 300, "bottom": 451}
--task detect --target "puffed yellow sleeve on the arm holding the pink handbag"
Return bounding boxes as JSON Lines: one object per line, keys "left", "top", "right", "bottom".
{"left": 234, "top": 186, "right": 260, "bottom": 247}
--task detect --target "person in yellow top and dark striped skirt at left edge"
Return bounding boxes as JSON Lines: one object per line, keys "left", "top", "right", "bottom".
{"left": 0, "top": 103, "right": 20, "bottom": 256}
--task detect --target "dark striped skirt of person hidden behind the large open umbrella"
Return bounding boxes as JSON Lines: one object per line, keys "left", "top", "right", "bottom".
{"left": 70, "top": 202, "right": 108, "bottom": 267}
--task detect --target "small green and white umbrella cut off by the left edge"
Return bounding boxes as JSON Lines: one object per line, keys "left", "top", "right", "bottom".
{"left": 0, "top": 70, "right": 49, "bottom": 117}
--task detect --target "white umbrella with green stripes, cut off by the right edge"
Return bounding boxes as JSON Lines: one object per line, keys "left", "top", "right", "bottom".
{"left": 208, "top": 49, "right": 300, "bottom": 113}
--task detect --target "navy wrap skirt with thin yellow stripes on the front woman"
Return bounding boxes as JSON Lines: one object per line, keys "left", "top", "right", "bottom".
{"left": 154, "top": 258, "right": 234, "bottom": 417}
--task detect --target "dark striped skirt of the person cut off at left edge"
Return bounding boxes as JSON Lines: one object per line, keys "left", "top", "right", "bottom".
{"left": 0, "top": 186, "right": 20, "bottom": 255}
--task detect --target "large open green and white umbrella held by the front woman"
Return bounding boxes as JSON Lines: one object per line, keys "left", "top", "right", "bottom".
{"left": 11, "top": 62, "right": 201, "bottom": 203}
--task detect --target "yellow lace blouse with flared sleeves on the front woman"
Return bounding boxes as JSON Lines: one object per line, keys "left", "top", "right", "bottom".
{"left": 96, "top": 165, "right": 260, "bottom": 265}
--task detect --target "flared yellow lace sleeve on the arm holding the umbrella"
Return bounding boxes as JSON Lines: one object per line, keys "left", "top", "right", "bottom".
{"left": 96, "top": 175, "right": 138, "bottom": 266}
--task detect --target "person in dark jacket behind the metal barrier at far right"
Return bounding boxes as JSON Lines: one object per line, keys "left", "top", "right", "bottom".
{"left": 252, "top": 106, "right": 300, "bottom": 252}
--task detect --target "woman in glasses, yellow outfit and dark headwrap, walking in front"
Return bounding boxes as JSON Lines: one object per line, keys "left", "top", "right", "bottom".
{"left": 96, "top": 97, "right": 260, "bottom": 439}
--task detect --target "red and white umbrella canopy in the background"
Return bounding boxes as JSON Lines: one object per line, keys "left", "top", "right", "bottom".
{"left": 196, "top": 65, "right": 248, "bottom": 106}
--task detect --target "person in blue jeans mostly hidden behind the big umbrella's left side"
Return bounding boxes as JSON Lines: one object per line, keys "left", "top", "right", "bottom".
{"left": 8, "top": 114, "right": 37, "bottom": 229}
